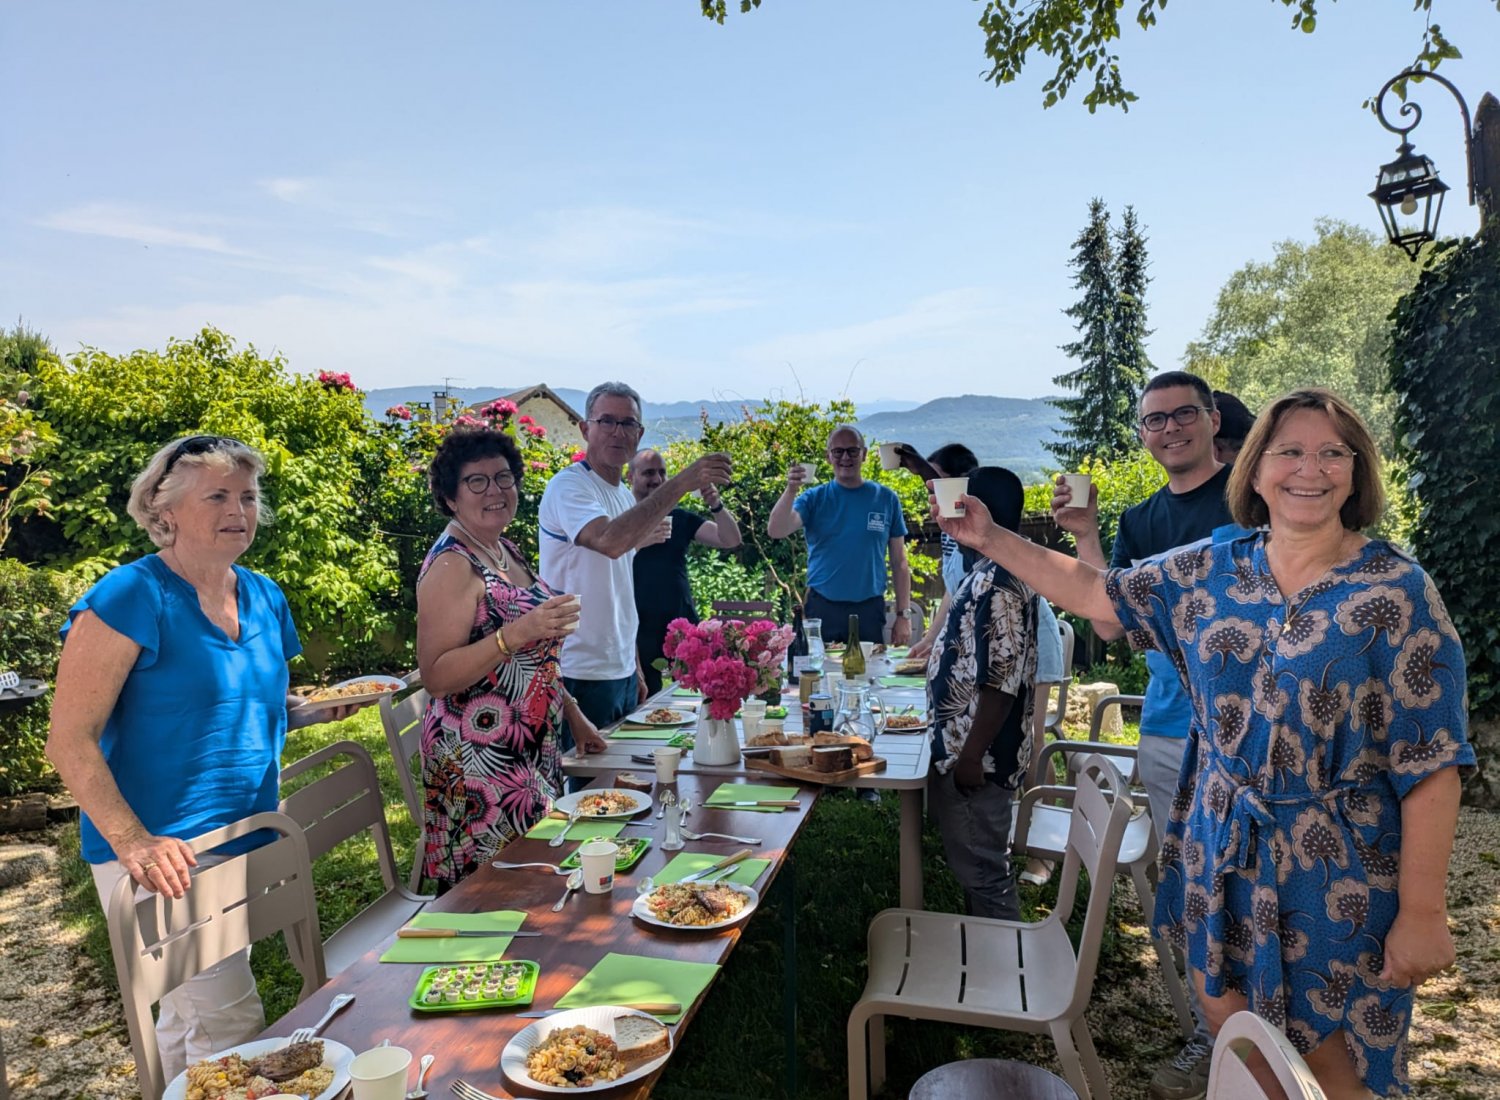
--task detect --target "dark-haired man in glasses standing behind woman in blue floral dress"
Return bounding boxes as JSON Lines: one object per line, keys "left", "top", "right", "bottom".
{"left": 1052, "top": 371, "right": 1241, "bottom": 1100}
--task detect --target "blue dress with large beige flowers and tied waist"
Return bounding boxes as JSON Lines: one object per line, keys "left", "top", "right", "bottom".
{"left": 1107, "top": 531, "right": 1475, "bottom": 1095}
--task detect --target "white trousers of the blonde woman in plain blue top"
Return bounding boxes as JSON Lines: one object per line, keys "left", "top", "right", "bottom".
{"left": 92, "top": 855, "right": 266, "bottom": 1082}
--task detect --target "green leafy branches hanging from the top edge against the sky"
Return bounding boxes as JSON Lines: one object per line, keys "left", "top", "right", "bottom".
{"left": 699, "top": 0, "right": 1476, "bottom": 114}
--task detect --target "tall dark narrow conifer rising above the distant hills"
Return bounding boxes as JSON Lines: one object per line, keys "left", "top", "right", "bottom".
{"left": 1047, "top": 198, "right": 1146, "bottom": 470}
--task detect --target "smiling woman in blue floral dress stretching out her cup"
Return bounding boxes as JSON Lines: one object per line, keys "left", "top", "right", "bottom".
{"left": 942, "top": 390, "right": 1475, "bottom": 1098}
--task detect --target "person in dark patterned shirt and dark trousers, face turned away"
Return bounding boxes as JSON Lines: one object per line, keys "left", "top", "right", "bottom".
{"left": 927, "top": 467, "right": 1037, "bottom": 920}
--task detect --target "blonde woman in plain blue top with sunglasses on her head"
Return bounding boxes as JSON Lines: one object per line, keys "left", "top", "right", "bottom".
{"left": 47, "top": 435, "right": 356, "bottom": 1079}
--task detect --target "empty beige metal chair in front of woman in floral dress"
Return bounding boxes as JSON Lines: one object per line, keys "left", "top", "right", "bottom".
{"left": 848, "top": 756, "right": 1131, "bottom": 1100}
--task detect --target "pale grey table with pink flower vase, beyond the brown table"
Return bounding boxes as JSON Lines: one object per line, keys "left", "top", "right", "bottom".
{"left": 563, "top": 683, "right": 932, "bottom": 909}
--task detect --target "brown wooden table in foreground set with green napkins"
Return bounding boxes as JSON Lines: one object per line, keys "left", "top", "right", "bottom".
{"left": 263, "top": 768, "right": 818, "bottom": 1100}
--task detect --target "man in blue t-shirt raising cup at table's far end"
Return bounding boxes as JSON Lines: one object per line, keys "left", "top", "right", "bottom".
{"left": 767, "top": 425, "right": 912, "bottom": 645}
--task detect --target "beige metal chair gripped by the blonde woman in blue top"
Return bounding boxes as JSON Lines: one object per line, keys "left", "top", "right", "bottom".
{"left": 110, "top": 813, "right": 326, "bottom": 1097}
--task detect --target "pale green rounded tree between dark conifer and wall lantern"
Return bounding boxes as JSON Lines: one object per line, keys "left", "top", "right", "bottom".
{"left": 1184, "top": 218, "right": 1421, "bottom": 455}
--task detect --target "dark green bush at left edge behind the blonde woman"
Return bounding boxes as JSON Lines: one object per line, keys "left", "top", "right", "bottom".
{"left": 0, "top": 558, "right": 86, "bottom": 795}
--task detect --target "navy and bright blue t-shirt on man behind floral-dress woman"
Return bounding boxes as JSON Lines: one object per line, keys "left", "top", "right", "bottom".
{"left": 1110, "top": 467, "right": 1247, "bottom": 738}
